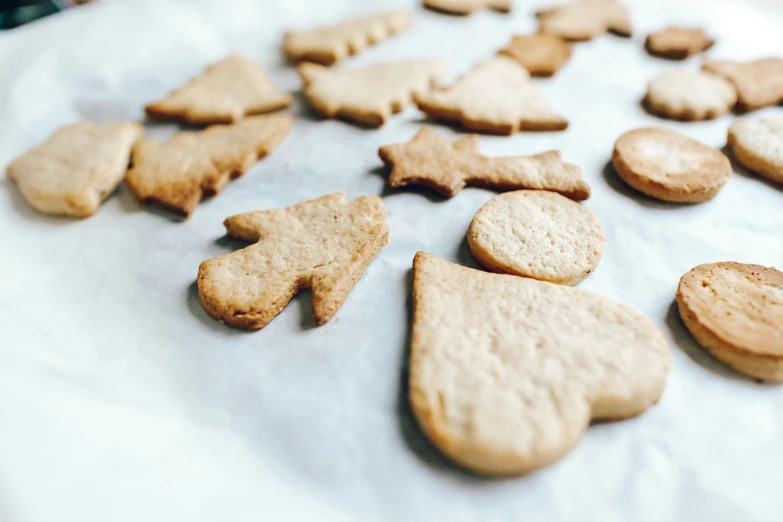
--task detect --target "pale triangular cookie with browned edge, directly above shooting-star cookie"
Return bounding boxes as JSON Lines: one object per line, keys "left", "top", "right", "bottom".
{"left": 416, "top": 56, "right": 568, "bottom": 134}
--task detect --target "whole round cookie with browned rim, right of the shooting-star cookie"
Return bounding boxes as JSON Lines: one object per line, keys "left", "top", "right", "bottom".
{"left": 612, "top": 128, "right": 732, "bottom": 203}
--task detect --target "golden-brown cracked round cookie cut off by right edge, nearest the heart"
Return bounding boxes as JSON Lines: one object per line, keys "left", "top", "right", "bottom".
{"left": 677, "top": 262, "right": 783, "bottom": 382}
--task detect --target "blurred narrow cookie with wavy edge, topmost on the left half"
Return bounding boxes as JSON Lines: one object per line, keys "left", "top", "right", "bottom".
{"left": 283, "top": 10, "right": 411, "bottom": 65}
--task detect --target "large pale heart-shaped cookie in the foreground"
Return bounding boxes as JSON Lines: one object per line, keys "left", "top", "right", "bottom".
{"left": 409, "top": 252, "right": 670, "bottom": 475}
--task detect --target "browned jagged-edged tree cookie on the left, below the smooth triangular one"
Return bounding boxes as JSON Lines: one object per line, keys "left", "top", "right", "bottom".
{"left": 127, "top": 115, "right": 291, "bottom": 217}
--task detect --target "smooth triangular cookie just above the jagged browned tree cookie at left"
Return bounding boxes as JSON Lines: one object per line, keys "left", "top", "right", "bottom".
{"left": 144, "top": 54, "right": 291, "bottom": 125}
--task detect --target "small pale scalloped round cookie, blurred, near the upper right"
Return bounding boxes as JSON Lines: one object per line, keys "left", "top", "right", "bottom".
{"left": 644, "top": 69, "right": 737, "bottom": 121}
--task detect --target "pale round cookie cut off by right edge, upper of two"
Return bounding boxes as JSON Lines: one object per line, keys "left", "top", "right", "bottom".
{"left": 728, "top": 116, "right": 783, "bottom": 183}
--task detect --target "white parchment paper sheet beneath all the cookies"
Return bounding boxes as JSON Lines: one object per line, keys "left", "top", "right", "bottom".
{"left": 0, "top": 0, "right": 783, "bottom": 522}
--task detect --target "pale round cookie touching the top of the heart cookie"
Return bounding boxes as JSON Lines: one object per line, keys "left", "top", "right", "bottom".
{"left": 468, "top": 190, "right": 606, "bottom": 285}
